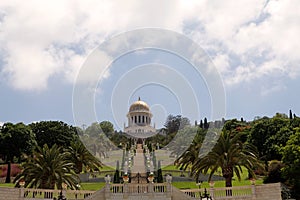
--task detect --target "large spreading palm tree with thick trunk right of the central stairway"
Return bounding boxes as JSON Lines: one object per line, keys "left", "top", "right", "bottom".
{"left": 192, "top": 131, "right": 261, "bottom": 187}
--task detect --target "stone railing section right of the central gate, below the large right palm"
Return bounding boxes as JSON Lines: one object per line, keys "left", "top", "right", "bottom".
{"left": 180, "top": 185, "right": 256, "bottom": 199}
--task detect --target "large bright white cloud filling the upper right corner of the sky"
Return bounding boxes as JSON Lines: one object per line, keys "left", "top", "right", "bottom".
{"left": 227, "top": 0, "right": 300, "bottom": 86}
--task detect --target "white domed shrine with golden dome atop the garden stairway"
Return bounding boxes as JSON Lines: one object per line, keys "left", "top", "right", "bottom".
{"left": 124, "top": 98, "right": 156, "bottom": 139}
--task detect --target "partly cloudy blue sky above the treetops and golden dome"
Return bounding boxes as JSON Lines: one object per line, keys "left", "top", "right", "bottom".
{"left": 0, "top": 0, "right": 300, "bottom": 130}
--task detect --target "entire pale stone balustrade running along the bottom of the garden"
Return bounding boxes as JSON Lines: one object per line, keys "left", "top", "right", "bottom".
{"left": 0, "top": 183, "right": 281, "bottom": 200}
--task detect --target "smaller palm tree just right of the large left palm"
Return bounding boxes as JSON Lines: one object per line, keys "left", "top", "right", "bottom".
{"left": 68, "top": 138, "right": 102, "bottom": 174}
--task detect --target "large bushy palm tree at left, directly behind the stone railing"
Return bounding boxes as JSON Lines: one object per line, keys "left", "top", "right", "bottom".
{"left": 14, "top": 144, "right": 79, "bottom": 189}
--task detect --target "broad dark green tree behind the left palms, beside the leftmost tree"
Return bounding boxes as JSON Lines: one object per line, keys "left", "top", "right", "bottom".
{"left": 29, "top": 121, "right": 77, "bottom": 148}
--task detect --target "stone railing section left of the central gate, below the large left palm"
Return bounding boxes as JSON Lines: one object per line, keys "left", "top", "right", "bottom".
{"left": 20, "top": 188, "right": 95, "bottom": 200}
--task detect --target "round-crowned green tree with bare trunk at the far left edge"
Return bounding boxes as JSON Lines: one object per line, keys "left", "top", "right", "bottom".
{"left": 0, "top": 123, "right": 35, "bottom": 183}
